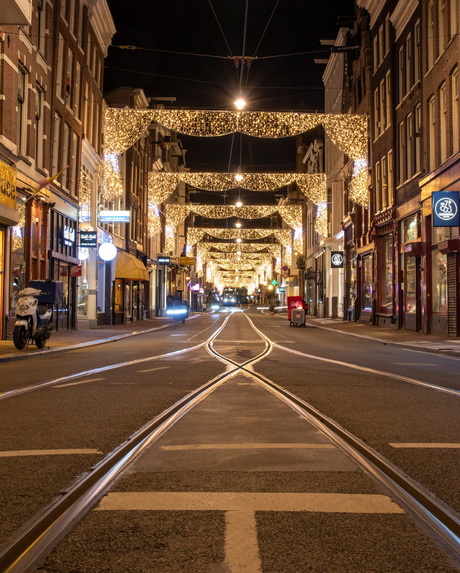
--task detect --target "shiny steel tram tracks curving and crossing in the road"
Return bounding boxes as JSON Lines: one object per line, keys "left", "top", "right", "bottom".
{"left": 0, "top": 313, "right": 460, "bottom": 573}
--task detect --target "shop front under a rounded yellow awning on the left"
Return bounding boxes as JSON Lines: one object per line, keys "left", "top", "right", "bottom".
{"left": 113, "top": 250, "right": 150, "bottom": 324}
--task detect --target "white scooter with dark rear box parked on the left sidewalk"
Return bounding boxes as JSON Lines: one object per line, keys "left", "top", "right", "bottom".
{"left": 13, "top": 287, "right": 53, "bottom": 350}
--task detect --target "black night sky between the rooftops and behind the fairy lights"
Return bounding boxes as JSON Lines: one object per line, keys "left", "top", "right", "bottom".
{"left": 104, "top": 0, "right": 353, "bottom": 177}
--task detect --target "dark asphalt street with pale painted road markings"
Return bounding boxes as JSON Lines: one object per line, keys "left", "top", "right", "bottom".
{"left": 0, "top": 307, "right": 460, "bottom": 573}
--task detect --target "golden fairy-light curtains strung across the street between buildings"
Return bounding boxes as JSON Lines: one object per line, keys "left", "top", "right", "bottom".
{"left": 102, "top": 104, "right": 369, "bottom": 284}
